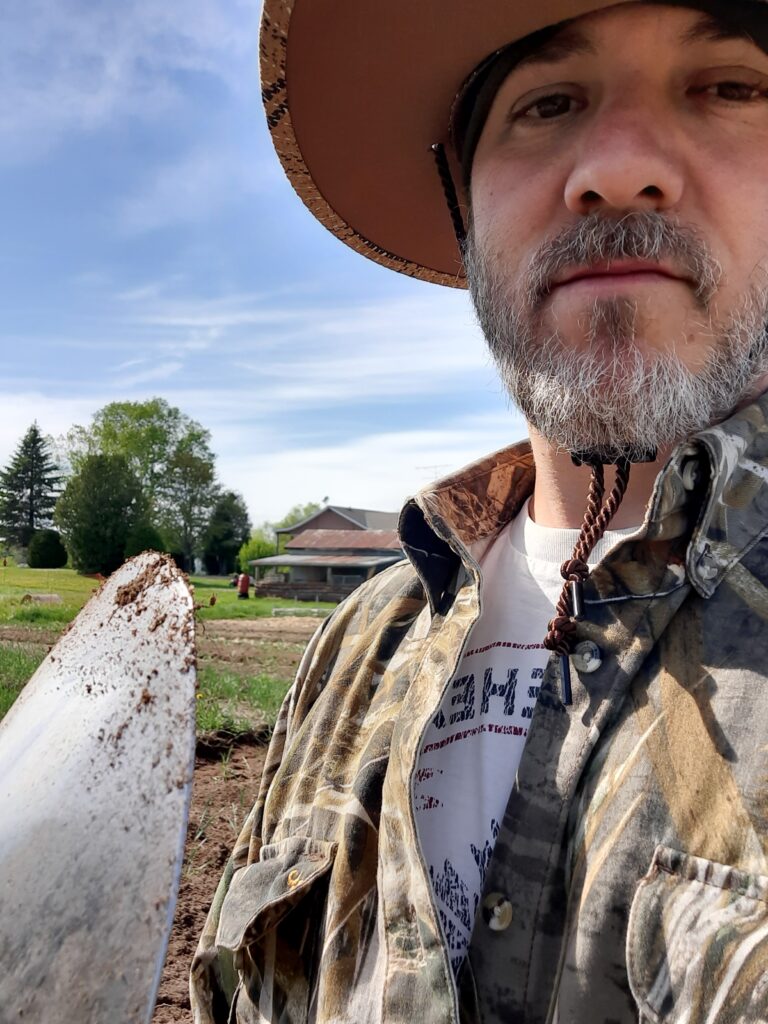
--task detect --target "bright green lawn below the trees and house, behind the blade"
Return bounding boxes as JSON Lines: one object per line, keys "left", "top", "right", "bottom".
{"left": 0, "top": 565, "right": 335, "bottom": 627}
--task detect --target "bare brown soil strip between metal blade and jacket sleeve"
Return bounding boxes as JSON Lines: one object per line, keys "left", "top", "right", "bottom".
{"left": 153, "top": 738, "right": 266, "bottom": 1024}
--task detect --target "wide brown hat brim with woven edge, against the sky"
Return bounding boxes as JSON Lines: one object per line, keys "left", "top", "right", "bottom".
{"left": 261, "top": 0, "right": 626, "bottom": 288}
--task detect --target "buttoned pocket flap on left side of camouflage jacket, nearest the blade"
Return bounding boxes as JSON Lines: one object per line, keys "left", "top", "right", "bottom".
{"left": 216, "top": 836, "right": 336, "bottom": 951}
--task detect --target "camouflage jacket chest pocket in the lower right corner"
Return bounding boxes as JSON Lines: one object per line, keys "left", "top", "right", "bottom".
{"left": 627, "top": 846, "right": 768, "bottom": 1024}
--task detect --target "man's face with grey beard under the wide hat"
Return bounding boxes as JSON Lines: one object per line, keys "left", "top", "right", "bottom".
{"left": 468, "top": 3, "right": 768, "bottom": 450}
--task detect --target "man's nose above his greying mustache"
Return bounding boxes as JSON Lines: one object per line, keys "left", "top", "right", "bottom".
{"left": 565, "top": 106, "right": 684, "bottom": 215}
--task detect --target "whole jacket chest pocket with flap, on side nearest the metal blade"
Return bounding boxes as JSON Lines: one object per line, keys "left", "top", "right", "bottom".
{"left": 216, "top": 836, "right": 336, "bottom": 1024}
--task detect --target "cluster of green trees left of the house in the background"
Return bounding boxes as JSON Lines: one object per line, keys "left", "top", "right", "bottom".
{"left": 0, "top": 398, "right": 317, "bottom": 575}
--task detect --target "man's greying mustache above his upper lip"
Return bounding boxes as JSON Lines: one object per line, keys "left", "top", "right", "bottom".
{"left": 524, "top": 211, "right": 723, "bottom": 309}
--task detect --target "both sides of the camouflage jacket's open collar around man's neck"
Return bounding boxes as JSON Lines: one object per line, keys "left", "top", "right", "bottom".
{"left": 399, "top": 392, "right": 768, "bottom": 610}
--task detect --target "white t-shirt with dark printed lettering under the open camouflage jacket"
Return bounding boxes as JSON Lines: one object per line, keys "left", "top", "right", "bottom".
{"left": 414, "top": 506, "right": 635, "bottom": 971}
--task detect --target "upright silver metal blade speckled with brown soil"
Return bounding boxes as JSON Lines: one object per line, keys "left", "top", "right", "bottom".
{"left": 0, "top": 552, "right": 195, "bottom": 1024}
